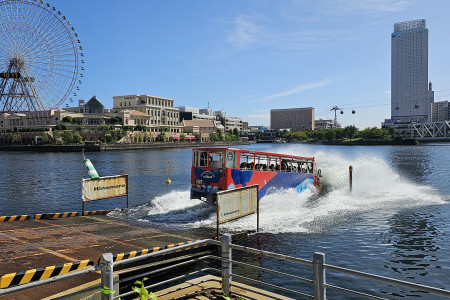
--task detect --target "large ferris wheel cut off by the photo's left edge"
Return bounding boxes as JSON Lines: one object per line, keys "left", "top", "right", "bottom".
{"left": 0, "top": 0, "right": 84, "bottom": 112}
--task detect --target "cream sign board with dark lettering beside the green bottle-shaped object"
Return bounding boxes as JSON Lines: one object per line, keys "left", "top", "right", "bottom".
{"left": 83, "top": 175, "right": 128, "bottom": 202}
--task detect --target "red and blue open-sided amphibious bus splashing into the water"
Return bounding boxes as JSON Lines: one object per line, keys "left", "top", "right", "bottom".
{"left": 191, "top": 147, "right": 320, "bottom": 202}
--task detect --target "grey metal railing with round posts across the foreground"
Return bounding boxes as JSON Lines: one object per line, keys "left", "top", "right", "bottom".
{"left": 0, "top": 235, "right": 450, "bottom": 300}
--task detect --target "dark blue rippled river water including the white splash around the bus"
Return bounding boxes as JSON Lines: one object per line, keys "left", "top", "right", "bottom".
{"left": 0, "top": 144, "right": 450, "bottom": 299}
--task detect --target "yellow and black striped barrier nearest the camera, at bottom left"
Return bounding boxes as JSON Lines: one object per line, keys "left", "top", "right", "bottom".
{"left": 0, "top": 259, "right": 94, "bottom": 289}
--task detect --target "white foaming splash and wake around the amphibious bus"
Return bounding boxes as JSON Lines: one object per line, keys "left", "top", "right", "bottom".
{"left": 113, "top": 147, "right": 445, "bottom": 233}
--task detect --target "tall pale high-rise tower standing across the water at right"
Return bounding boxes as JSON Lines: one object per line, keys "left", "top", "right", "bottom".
{"left": 391, "top": 19, "right": 434, "bottom": 124}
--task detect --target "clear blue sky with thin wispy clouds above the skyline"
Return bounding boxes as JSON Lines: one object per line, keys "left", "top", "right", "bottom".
{"left": 55, "top": 0, "right": 450, "bottom": 129}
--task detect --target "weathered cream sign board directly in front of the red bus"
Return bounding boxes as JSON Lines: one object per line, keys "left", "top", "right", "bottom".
{"left": 217, "top": 185, "right": 258, "bottom": 224}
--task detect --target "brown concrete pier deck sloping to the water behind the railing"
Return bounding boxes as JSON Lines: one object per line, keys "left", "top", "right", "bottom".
{"left": 0, "top": 215, "right": 212, "bottom": 300}
